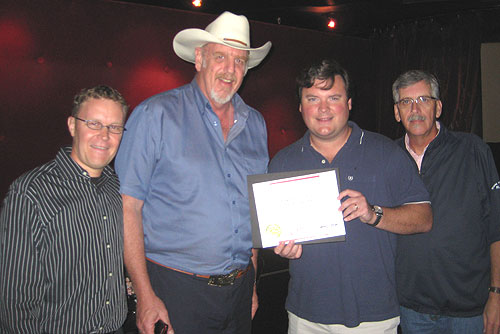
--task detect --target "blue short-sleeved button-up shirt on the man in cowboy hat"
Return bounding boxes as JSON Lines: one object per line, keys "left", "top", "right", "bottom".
{"left": 115, "top": 80, "right": 268, "bottom": 275}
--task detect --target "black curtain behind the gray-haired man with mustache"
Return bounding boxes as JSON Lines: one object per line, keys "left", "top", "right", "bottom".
{"left": 371, "top": 12, "right": 482, "bottom": 138}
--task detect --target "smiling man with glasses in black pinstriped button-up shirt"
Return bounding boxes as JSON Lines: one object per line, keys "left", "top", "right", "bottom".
{"left": 0, "top": 86, "right": 128, "bottom": 334}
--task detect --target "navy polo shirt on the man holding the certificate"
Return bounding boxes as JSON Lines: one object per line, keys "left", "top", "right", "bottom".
{"left": 269, "top": 122, "right": 429, "bottom": 327}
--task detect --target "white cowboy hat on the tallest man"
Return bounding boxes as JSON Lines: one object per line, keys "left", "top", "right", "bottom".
{"left": 173, "top": 12, "right": 271, "bottom": 69}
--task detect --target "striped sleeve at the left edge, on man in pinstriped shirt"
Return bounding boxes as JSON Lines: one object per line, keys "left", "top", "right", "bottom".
{"left": 0, "top": 191, "right": 44, "bottom": 333}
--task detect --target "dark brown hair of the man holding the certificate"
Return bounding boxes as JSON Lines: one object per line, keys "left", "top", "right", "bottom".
{"left": 296, "top": 59, "right": 349, "bottom": 100}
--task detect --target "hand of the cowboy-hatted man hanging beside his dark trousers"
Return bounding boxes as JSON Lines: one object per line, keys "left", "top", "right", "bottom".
{"left": 136, "top": 295, "right": 174, "bottom": 334}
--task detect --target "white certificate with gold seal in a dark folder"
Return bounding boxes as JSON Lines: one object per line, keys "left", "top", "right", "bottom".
{"left": 248, "top": 169, "right": 345, "bottom": 248}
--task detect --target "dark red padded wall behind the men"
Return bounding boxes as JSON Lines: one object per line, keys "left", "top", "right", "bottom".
{"left": 0, "top": 0, "right": 375, "bottom": 198}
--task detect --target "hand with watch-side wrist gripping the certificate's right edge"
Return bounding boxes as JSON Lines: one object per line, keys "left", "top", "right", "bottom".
{"left": 337, "top": 189, "right": 376, "bottom": 223}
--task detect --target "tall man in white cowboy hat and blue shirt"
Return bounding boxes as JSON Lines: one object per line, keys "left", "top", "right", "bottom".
{"left": 115, "top": 12, "right": 271, "bottom": 334}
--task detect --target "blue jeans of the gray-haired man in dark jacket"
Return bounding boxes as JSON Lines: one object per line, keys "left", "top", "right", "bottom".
{"left": 400, "top": 306, "right": 484, "bottom": 334}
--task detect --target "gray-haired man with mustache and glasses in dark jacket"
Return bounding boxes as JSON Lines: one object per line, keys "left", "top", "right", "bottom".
{"left": 392, "top": 70, "right": 500, "bottom": 334}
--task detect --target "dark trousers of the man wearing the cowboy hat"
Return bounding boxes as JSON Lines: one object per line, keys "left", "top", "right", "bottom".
{"left": 147, "top": 261, "right": 255, "bottom": 334}
